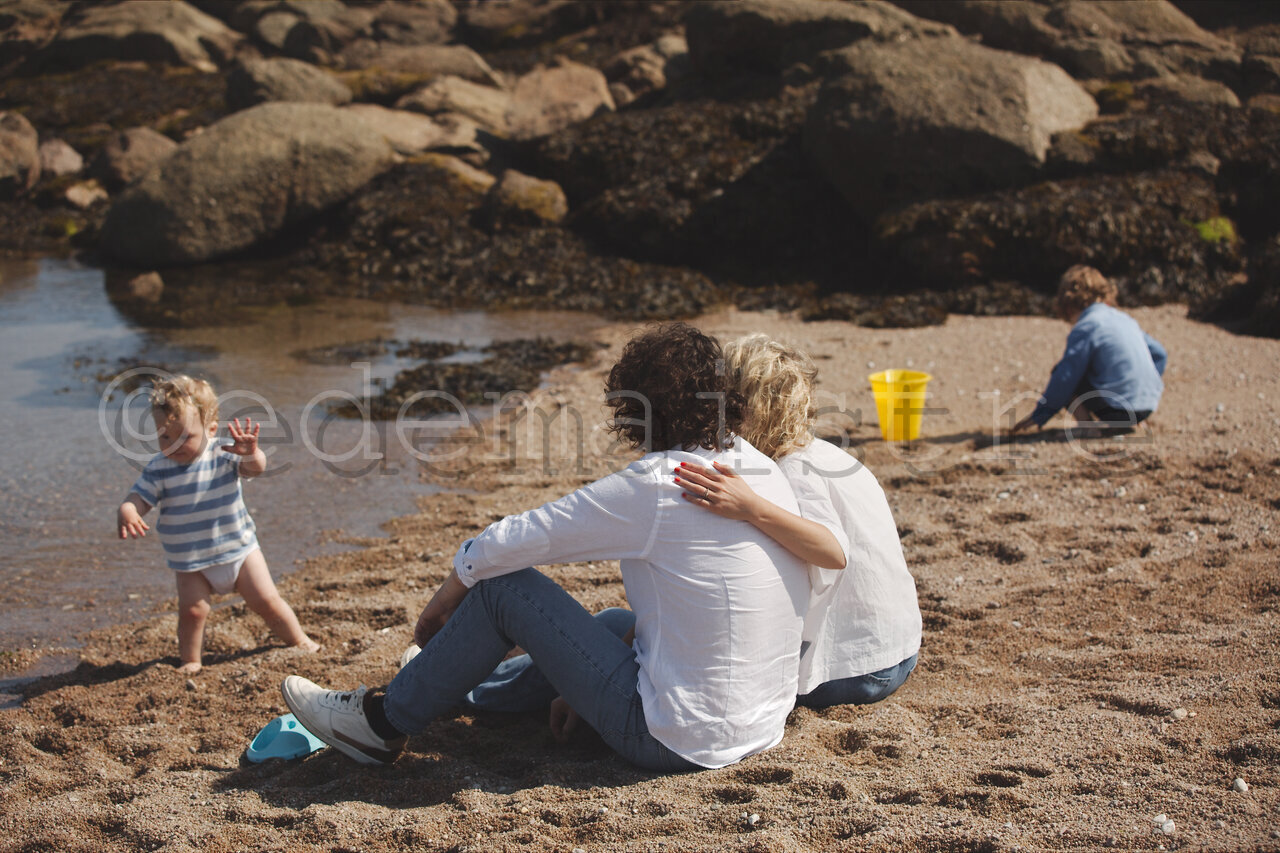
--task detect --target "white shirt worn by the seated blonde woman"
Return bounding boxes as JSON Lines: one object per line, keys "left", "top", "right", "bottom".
{"left": 778, "top": 439, "right": 920, "bottom": 695}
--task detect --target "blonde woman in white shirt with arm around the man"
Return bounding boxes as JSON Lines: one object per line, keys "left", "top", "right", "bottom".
{"left": 677, "top": 334, "right": 922, "bottom": 708}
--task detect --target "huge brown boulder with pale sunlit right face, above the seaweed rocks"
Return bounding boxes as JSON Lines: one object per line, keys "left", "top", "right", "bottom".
{"left": 805, "top": 37, "right": 1098, "bottom": 219}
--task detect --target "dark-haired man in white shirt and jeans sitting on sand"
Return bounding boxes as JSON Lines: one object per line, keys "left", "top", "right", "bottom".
{"left": 282, "top": 324, "right": 809, "bottom": 772}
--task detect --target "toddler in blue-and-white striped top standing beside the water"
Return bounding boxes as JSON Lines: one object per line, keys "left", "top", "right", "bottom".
{"left": 116, "top": 377, "right": 320, "bottom": 675}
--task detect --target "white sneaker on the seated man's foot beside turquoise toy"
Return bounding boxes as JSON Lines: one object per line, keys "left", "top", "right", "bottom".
{"left": 280, "top": 675, "right": 408, "bottom": 765}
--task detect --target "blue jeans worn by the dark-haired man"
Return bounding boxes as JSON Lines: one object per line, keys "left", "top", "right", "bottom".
{"left": 383, "top": 569, "right": 698, "bottom": 772}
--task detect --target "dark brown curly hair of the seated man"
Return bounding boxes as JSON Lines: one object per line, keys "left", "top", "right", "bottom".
{"left": 604, "top": 323, "right": 742, "bottom": 452}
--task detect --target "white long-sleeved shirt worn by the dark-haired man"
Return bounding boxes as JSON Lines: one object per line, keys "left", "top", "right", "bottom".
{"left": 453, "top": 438, "right": 809, "bottom": 767}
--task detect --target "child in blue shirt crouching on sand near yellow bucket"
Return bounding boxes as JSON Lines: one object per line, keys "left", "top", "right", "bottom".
{"left": 1012, "top": 264, "right": 1169, "bottom": 433}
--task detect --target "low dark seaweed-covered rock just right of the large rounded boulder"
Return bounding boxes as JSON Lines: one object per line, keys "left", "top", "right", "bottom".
{"left": 293, "top": 154, "right": 726, "bottom": 319}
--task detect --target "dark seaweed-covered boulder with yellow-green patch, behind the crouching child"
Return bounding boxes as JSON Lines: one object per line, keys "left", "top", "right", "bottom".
{"left": 876, "top": 169, "right": 1243, "bottom": 305}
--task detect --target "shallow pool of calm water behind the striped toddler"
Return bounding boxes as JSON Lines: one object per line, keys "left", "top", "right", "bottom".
{"left": 0, "top": 260, "right": 604, "bottom": 649}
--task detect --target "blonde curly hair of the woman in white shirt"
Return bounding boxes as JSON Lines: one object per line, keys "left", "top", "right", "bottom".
{"left": 724, "top": 334, "right": 818, "bottom": 459}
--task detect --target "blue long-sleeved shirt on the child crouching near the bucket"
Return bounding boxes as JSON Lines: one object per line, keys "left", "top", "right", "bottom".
{"left": 1032, "top": 302, "right": 1169, "bottom": 427}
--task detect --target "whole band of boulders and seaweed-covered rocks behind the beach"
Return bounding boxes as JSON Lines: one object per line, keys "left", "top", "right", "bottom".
{"left": 0, "top": 0, "right": 1280, "bottom": 334}
